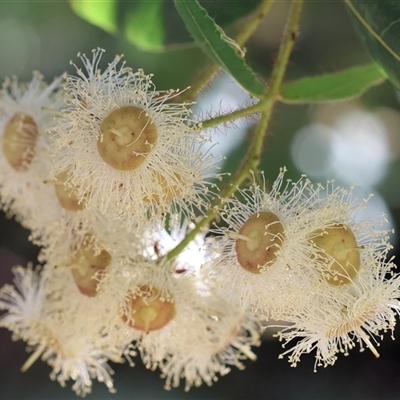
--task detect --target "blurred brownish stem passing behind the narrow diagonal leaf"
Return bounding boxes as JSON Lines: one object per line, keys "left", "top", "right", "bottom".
{"left": 179, "top": 0, "right": 274, "bottom": 103}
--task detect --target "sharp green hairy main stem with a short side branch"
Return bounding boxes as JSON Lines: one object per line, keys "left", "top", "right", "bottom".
{"left": 166, "top": 0, "right": 303, "bottom": 260}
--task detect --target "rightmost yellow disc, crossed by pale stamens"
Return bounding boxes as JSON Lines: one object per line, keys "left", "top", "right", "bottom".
{"left": 311, "top": 224, "right": 360, "bottom": 286}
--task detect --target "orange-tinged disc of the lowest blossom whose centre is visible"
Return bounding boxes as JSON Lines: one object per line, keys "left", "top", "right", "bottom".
{"left": 122, "top": 285, "right": 175, "bottom": 333}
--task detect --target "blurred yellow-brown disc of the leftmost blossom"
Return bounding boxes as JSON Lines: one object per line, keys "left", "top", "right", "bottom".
{"left": 3, "top": 113, "right": 38, "bottom": 171}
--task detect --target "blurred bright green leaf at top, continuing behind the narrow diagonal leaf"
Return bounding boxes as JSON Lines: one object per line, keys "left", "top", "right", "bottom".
{"left": 70, "top": 0, "right": 261, "bottom": 52}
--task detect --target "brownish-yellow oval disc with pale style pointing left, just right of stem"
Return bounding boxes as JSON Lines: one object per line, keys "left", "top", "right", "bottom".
{"left": 233, "top": 211, "right": 284, "bottom": 274}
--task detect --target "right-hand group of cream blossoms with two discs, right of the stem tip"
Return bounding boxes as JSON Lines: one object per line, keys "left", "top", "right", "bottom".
{"left": 207, "top": 171, "right": 400, "bottom": 366}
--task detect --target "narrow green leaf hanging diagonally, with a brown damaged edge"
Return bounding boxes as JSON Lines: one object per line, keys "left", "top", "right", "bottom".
{"left": 174, "top": 0, "right": 264, "bottom": 96}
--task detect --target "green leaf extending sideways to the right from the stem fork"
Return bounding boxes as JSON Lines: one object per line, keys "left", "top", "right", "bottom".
{"left": 281, "top": 64, "right": 385, "bottom": 104}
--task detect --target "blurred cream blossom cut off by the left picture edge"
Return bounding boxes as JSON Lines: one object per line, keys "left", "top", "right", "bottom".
{"left": 0, "top": 72, "right": 63, "bottom": 227}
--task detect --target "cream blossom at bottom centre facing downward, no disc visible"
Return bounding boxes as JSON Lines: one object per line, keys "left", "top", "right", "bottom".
{"left": 160, "top": 293, "right": 261, "bottom": 391}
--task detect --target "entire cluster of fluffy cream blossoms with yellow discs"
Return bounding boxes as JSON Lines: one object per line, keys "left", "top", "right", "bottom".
{"left": 0, "top": 50, "right": 400, "bottom": 396}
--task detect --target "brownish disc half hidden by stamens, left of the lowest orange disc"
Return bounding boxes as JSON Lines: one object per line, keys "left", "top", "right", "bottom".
{"left": 71, "top": 246, "right": 111, "bottom": 297}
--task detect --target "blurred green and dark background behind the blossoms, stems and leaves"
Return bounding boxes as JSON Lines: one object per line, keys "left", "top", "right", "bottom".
{"left": 0, "top": 0, "right": 400, "bottom": 400}
